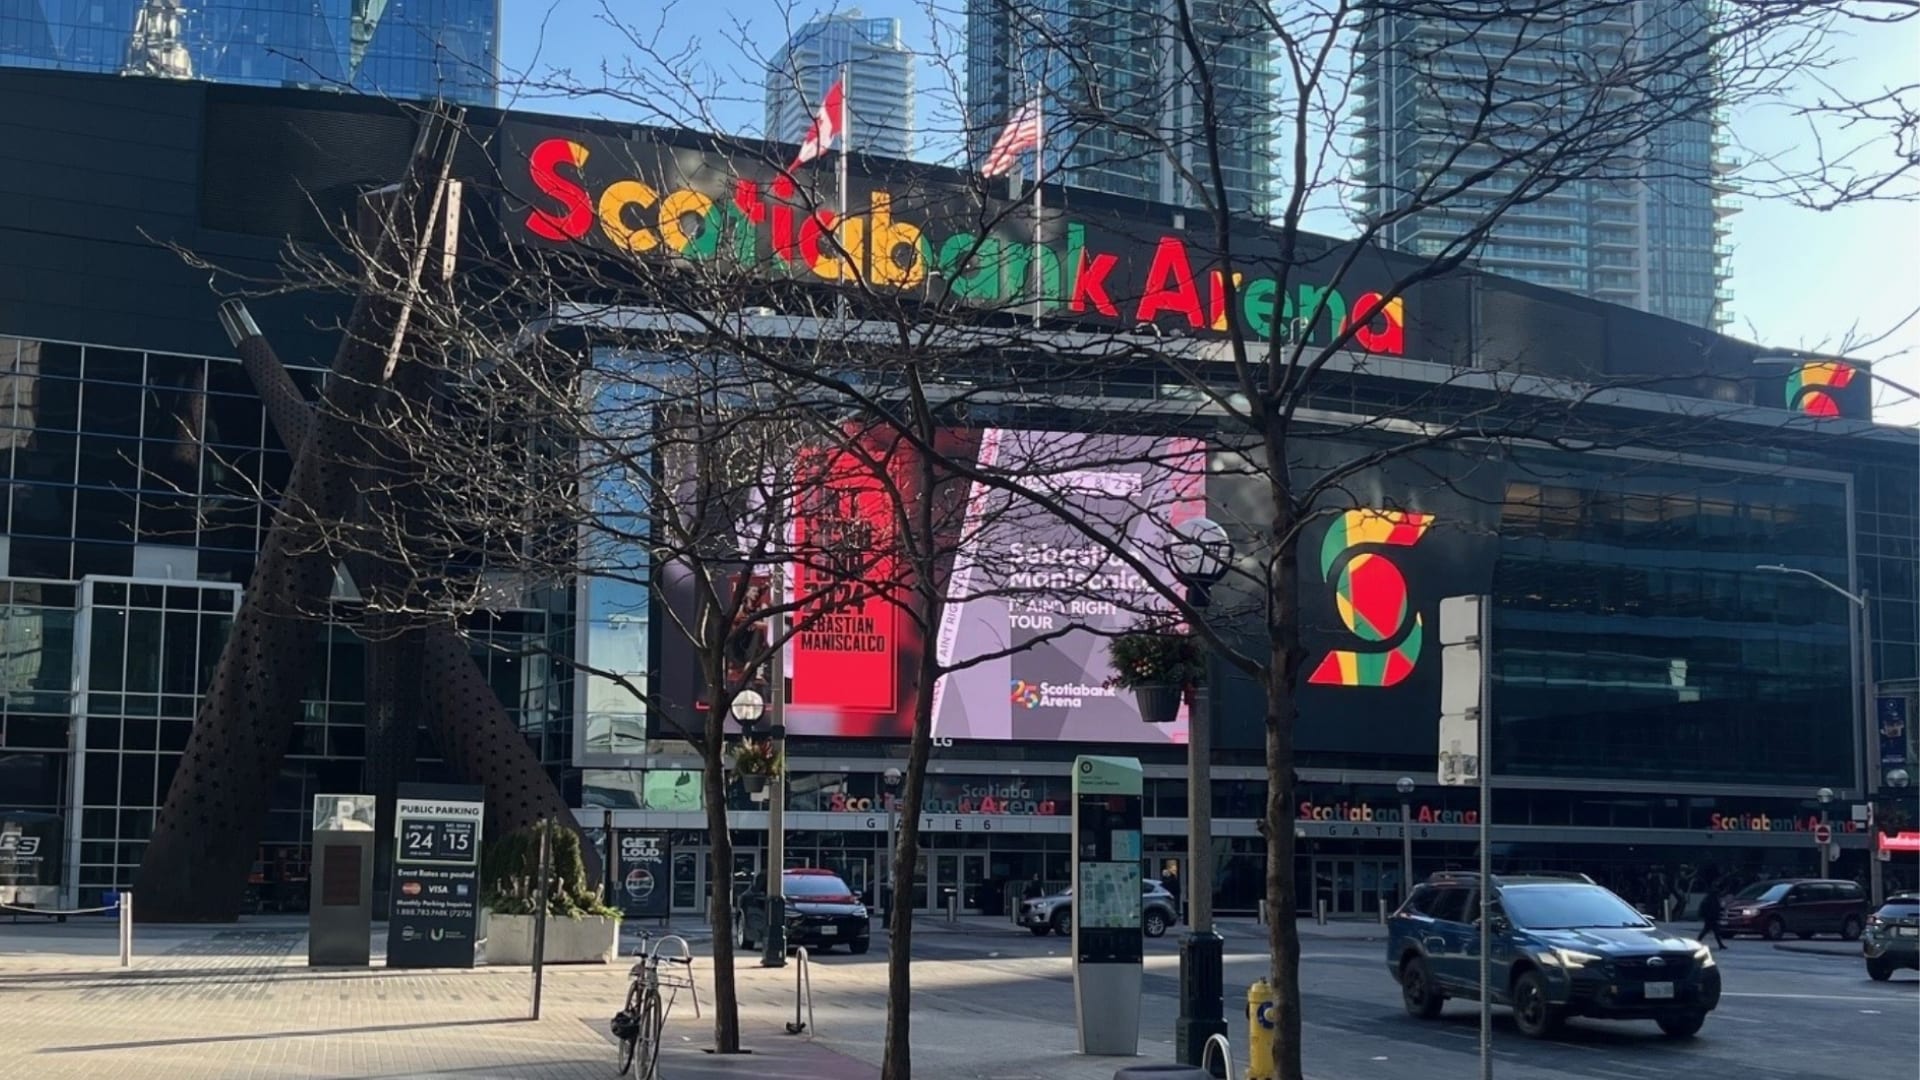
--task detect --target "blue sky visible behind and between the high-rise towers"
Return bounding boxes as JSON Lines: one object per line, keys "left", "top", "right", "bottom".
{"left": 501, "top": 0, "right": 1920, "bottom": 425}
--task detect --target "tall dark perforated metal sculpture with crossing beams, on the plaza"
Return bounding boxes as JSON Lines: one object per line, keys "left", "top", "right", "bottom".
{"left": 134, "top": 113, "right": 587, "bottom": 922}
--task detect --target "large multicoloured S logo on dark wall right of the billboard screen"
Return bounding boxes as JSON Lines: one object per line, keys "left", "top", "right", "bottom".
{"left": 1308, "top": 509, "right": 1434, "bottom": 686}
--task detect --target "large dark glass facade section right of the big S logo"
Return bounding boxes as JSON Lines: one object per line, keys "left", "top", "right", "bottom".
{"left": 1494, "top": 445, "right": 1859, "bottom": 788}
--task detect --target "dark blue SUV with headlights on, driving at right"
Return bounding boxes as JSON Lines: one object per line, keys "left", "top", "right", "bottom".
{"left": 1386, "top": 874, "right": 1720, "bottom": 1038}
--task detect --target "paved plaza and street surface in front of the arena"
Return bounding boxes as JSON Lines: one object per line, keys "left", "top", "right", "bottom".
{"left": 0, "top": 907, "right": 1920, "bottom": 1080}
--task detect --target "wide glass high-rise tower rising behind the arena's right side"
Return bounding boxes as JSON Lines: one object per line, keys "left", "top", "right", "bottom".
{"left": 1354, "top": 0, "right": 1734, "bottom": 327}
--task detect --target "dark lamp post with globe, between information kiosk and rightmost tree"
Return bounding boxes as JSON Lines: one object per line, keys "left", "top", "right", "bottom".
{"left": 1167, "top": 517, "right": 1233, "bottom": 1065}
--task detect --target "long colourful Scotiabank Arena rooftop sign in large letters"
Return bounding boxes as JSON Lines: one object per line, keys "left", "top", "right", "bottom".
{"left": 499, "top": 123, "right": 1407, "bottom": 356}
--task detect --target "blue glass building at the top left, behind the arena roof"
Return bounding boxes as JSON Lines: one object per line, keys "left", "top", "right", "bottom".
{"left": 0, "top": 0, "right": 499, "bottom": 106}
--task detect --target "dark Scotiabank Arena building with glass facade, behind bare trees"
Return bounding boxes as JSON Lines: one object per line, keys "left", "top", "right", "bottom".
{"left": 0, "top": 69, "right": 1920, "bottom": 915}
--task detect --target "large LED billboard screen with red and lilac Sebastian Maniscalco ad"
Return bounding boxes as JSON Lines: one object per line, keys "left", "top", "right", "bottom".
{"left": 655, "top": 429, "right": 1206, "bottom": 744}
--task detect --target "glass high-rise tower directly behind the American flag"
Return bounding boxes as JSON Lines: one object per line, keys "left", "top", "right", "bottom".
{"left": 966, "top": 0, "right": 1273, "bottom": 217}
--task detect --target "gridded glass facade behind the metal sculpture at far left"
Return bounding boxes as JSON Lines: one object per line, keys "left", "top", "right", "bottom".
{"left": 0, "top": 338, "right": 578, "bottom": 909}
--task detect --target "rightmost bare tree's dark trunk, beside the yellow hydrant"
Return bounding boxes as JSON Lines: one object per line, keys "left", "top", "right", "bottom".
{"left": 1265, "top": 488, "right": 1304, "bottom": 1080}
